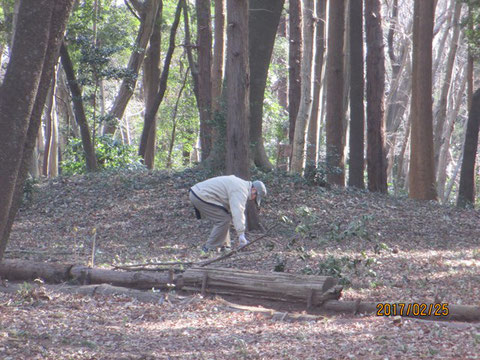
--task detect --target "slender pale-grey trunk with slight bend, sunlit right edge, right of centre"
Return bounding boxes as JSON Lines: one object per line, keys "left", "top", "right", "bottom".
{"left": 290, "top": 0, "right": 314, "bottom": 174}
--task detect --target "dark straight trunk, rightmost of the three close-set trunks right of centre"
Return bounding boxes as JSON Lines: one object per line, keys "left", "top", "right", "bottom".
{"left": 365, "top": 0, "right": 387, "bottom": 193}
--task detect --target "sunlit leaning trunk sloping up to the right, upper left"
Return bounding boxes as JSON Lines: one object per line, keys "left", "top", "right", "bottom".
{"left": 104, "top": 0, "right": 161, "bottom": 134}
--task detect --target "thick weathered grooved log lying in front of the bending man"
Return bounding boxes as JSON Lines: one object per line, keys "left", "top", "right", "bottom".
{"left": 177, "top": 267, "right": 341, "bottom": 308}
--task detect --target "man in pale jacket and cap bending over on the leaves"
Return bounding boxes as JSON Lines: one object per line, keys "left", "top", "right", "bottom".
{"left": 189, "top": 175, "right": 267, "bottom": 252}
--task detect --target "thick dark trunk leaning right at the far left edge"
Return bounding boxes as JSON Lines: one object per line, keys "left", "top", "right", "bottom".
{"left": 0, "top": 0, "right": 73, "bottom": 260}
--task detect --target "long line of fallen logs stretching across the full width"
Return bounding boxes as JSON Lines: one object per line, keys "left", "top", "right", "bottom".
{"left": 0, "top": 260, "right": 480, "bottom": 321}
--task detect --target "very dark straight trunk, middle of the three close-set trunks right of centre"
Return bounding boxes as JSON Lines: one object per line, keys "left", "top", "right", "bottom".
{"left": 348, "top": 0, "right": 365, "bottom": 189}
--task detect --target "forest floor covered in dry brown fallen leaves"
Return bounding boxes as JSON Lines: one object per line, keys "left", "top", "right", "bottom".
{"left": 0, "top": 171, "right": 480, "bottom": 360}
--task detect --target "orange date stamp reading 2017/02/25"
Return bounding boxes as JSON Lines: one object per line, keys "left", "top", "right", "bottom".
{"left": 377, "top": 303, "right": 449, "bottom": 316}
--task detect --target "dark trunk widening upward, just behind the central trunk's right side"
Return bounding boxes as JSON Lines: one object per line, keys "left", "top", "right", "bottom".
{"left": 248, "top": 0, "right": 285, "bottom": 171}
